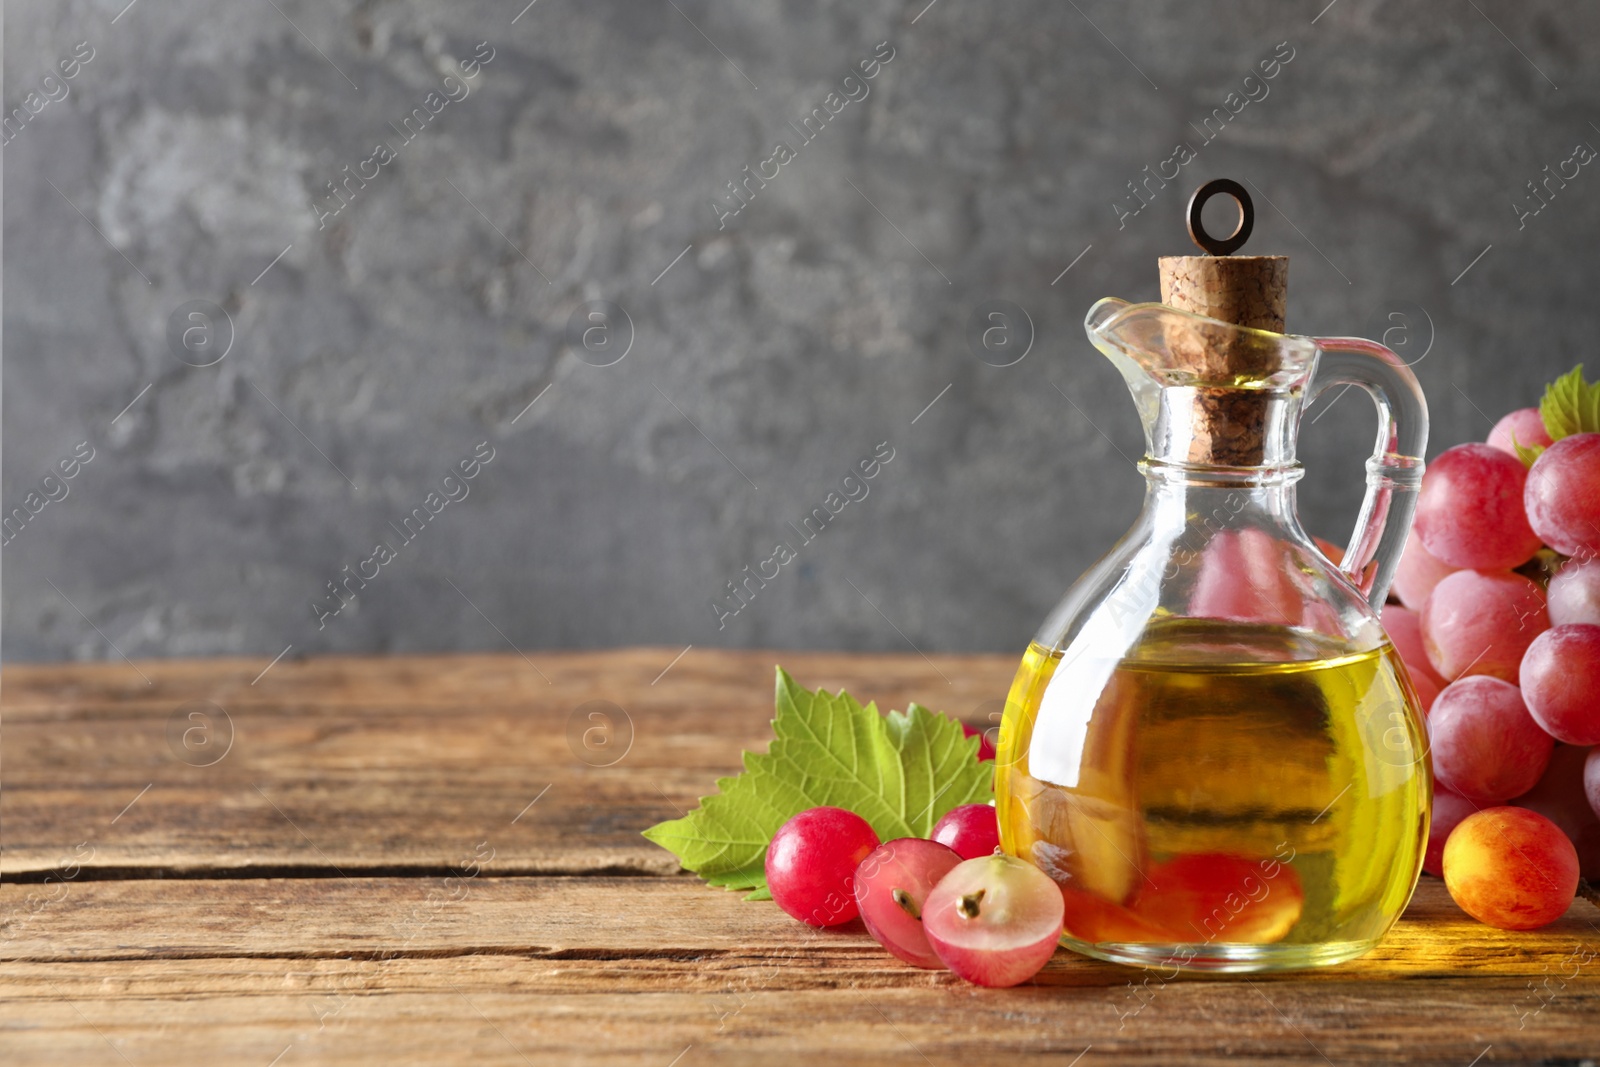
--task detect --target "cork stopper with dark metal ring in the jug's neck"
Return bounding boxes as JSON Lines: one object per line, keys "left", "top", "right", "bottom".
{"left": 1160, "top": 179, "right": 1290, "bottom": 467}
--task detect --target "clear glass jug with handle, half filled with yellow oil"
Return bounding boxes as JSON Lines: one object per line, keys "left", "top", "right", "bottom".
{"left": 995, "top": 299, "right": 1432, "bottom": 971}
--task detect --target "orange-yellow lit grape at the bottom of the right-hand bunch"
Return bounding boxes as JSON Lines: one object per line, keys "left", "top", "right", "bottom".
{"left": 1445, "top": 808, "right": 1578, "bottom": 929}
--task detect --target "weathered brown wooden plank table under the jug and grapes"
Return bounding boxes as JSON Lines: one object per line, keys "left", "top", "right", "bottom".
{"left": 0, "top": 649, "right": 1600, "bottom": 1067}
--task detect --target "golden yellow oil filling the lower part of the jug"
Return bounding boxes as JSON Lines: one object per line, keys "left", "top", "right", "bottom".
{"left": 995, "top": 619, "right": 1432, "bottom": 969}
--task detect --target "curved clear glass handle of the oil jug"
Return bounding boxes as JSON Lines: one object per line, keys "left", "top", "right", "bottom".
{"left": 1302, "top": 338, "right": 1427, "bottom": 611}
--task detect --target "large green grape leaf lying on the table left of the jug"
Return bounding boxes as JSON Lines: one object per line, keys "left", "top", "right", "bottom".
{"left": 645, "top": 667, "right": 994, "bottom": 901}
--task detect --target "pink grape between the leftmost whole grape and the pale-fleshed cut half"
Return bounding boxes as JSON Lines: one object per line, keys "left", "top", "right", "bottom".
{"left": 856, "top": 837, "right": 962, "bottom": 971}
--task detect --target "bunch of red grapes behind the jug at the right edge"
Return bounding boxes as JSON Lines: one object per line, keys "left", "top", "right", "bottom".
{"left": 1384, "top": 396, "right": 1600, "bottom": 929}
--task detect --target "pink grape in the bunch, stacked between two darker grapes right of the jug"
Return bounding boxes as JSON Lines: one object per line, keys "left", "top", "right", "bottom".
{"left": 1422, "top": 571, "right": 1550, "bottom": 683}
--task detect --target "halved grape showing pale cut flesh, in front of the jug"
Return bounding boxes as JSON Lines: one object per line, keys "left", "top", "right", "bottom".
{"left": 922, "top": 853, "right": 1067, "bottom": 989}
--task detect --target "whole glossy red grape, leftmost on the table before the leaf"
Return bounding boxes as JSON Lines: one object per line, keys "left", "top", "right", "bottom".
{"left": 766, "top": 808, "right": 878, "bottom": 926}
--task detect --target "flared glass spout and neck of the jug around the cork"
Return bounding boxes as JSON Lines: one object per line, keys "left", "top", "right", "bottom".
{"left": 1083, "top": 298, "right": 1318, "bottom": 469}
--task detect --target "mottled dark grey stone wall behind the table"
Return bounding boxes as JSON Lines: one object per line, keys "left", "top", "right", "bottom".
{"left": 0, "top": 0, "right": 1600, "bottom": 662}
